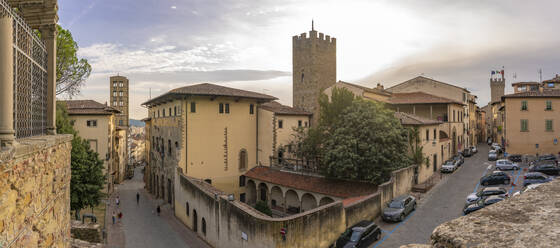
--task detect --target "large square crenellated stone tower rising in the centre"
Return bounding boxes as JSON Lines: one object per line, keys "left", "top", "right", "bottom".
{"left": 292, "top": 22, "right": 336, "bottom": 125}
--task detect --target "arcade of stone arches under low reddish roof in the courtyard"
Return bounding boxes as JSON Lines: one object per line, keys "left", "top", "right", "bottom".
{"left": 246, "top": 178, "right": 336, "bottom": 216}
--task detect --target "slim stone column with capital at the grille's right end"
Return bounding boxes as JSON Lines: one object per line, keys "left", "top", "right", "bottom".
{"left": 40, "top": 24, "right": 58, "bottom": 134}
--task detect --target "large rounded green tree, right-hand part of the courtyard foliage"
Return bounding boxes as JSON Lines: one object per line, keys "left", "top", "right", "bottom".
{"left": 321, "top": 99, "right": 410, "bottom": 184}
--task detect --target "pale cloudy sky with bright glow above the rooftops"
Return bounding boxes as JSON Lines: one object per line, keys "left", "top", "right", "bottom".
{"left": 58, "top": 0, "right": 560, "bottom": 119}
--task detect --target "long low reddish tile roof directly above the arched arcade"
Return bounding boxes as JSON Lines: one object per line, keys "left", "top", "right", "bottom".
{"left": 245, "top": 166, "right": 377, "bottom": 198}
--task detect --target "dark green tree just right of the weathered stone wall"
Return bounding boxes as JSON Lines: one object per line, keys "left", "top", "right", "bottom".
{"left": 56, "top": 102, "right": 105, "bottom": 220}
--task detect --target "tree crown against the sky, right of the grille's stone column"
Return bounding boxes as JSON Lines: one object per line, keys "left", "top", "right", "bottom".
{"left": 56, "top": 25, "right": 91, "bottom": 96}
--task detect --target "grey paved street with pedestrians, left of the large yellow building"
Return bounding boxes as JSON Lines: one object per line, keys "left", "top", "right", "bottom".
{"left": 107, "top": 167, "right": 210, "bottom": 248}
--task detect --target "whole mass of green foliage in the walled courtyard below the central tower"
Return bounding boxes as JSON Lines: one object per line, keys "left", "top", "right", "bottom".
{"left": 292, "top": 88, "right": 411, "bottom": 183}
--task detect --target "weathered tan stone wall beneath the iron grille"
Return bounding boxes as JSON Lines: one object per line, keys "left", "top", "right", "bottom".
{"left": 0, "top": 135, "right": 72, "bottom": 247}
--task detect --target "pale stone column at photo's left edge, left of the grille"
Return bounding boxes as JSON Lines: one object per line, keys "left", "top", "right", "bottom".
{"left": 0, "top": 13, "right": 15, "bottom": 148}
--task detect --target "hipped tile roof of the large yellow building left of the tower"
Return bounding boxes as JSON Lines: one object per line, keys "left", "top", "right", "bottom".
{"left": 142, "top": 83, "right": 277, "bottom": 105}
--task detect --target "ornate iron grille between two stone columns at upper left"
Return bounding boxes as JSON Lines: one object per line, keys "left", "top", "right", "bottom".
{"left": 0, "top": 0, "right": 47, "bottom": 139}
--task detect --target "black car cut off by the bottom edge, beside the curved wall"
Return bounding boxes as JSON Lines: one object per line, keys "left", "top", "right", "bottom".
{"left": 335, "top": 220, "right": 381, "bottom": 248}
